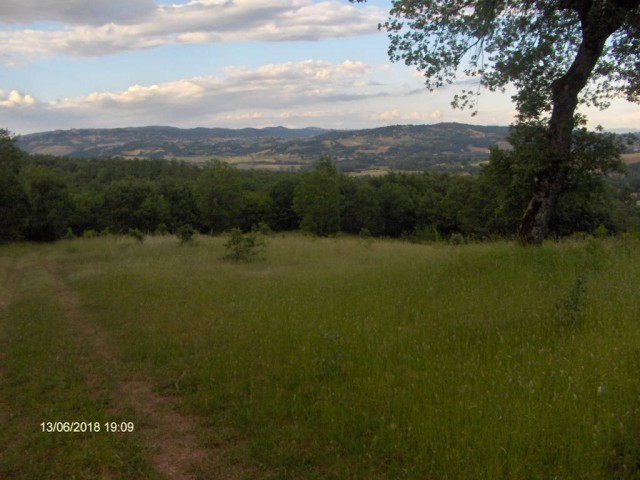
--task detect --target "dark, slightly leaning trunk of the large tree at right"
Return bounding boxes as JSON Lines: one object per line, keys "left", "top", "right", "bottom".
{"left": 518, "top": 7, "right": 620, "bottom": 245}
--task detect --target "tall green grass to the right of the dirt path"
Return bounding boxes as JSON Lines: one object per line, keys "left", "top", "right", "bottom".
{"left": 1, "top": 236, "right": 640, "bottom": 479}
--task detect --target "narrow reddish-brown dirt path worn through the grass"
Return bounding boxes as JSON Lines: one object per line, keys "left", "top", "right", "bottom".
{"left": 47, "top": 262, "right": 243, "bottom": 480}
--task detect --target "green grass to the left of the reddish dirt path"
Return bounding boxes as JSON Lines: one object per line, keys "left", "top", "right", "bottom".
{"left": 0, "top": 247, "right": 157, "bottom": 480}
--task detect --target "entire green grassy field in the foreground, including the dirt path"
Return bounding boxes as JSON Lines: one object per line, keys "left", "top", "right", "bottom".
{"left": 0, "top": 235, "right": 640, "bottom": 480}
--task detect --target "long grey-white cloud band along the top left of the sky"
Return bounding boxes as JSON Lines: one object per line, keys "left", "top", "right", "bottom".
{"left": 0, "top": 0, "right": 383, "bottom": 65}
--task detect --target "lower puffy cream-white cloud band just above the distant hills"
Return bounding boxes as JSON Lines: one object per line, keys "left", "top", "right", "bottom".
{"left": 0, "top": 60, "right": 385, "bottom": 131}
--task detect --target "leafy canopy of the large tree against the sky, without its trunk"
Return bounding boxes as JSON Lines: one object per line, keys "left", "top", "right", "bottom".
{"left": 351, "top": 0, "right": 640, "bottom": 120}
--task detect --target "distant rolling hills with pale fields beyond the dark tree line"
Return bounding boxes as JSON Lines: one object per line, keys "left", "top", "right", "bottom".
{"left": 18, "top": 123, "right": 508, "bottom": 171}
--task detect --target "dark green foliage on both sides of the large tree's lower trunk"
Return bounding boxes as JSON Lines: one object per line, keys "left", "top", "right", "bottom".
{"left": 479, "top": 122, "right": 625, "bottom": 235}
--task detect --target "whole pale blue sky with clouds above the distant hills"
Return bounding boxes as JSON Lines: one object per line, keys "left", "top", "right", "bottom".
{"left": 0, "top": 0, "right": 640, "bottom": 134}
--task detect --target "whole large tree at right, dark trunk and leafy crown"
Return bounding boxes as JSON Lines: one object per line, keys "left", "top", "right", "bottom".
{"left": 350, "top": 0, "right": 640, "bottom": 244}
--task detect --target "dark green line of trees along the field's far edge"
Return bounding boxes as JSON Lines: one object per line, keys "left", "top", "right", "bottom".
{"left": 0, "top": 128, "right": 640, "bottom": 241}
